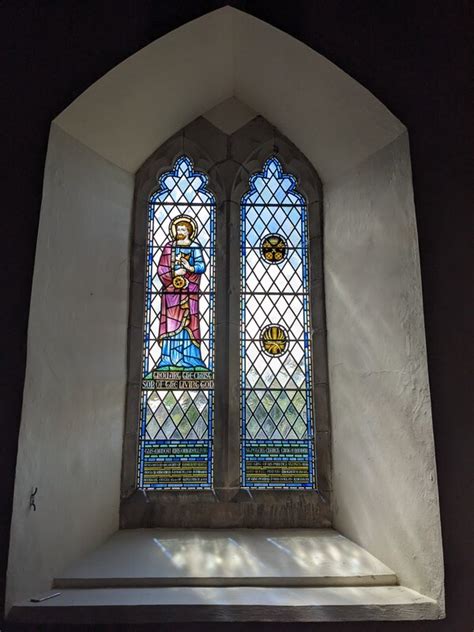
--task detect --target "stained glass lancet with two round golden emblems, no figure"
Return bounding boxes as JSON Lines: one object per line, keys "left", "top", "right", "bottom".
{"left": 240, "top": 157, "right": 314, "bottom": 489}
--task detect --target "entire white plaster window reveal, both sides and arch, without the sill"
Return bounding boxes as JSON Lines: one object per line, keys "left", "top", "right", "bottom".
{"left": 7, "top": 2, "right": 444, "bottom": 614}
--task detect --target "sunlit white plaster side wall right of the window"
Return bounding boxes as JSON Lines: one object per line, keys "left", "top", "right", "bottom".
{"left": 324, "top": 133, "right": 443, "bottom": 604}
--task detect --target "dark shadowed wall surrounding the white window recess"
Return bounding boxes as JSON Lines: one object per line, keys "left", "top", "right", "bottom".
{"left": 0, "top": 0, "right": 474, "bottom": 632}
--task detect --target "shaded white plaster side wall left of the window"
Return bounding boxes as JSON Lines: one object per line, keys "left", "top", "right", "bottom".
{"left": 7, "top": 125, "right": 133, "bottom": 608}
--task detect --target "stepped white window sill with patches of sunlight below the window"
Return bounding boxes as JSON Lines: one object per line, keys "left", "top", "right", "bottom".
{"left": 8, "top": 529, "right": 440, "bottom": 624}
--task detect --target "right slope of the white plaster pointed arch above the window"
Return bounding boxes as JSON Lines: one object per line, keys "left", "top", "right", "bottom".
{"left": 231, "top": 11, "right": 405, "bottom": 182}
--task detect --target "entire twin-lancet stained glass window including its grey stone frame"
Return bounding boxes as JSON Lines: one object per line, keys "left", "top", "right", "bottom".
{"left": 121, "top": 117, "right": 330, "bottom": 527}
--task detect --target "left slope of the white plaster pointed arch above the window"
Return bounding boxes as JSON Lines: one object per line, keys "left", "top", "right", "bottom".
{"left": 55, "top": 7, "right": 233, "bottom": 178}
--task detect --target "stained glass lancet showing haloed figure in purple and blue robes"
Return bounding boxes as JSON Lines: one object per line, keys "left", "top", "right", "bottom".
{"left": 138, "top": 156, "right": 215, "bottom": 489}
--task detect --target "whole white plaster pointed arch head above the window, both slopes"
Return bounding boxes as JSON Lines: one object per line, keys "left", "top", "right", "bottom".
{"left": 56, "top": 7, "right": 405, "bottom": 181}
